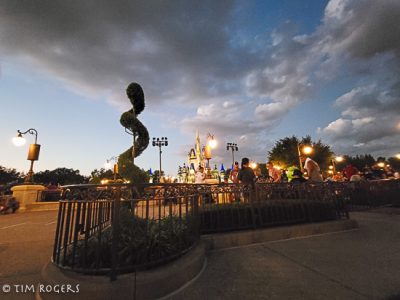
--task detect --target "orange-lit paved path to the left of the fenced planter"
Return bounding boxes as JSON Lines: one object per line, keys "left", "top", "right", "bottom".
{"left": 0, "top": 211, "right": 57, "bottom": 300}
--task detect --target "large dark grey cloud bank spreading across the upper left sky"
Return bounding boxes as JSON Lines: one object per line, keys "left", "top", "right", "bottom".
{"left": 0, "top": 1, "right": 252, "bottom": 107}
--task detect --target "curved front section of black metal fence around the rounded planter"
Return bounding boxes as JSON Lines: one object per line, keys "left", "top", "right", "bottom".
{"left": 53, "top": 184, "right": 199, "bottom": 278}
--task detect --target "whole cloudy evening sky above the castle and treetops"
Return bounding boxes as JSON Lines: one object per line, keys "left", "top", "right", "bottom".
{"left": 0, "top": 0, "right": 400, "bottom": 175}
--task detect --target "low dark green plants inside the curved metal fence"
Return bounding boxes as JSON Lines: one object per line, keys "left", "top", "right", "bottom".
{"left": 66, "top": 208, "right": 195, "bottom": 269}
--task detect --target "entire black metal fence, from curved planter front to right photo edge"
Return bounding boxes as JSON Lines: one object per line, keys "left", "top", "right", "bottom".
{"left": 53, "top": 181, "right": 400, "bottom": 278}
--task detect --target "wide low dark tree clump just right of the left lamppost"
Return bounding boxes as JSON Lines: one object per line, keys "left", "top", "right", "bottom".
{"left": 33, "top": 168, "right": 88, "bottom": 185}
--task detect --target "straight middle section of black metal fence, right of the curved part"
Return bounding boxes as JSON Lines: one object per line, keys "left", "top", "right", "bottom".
{"left": 199, "top": 183, "right": 348, "bottom": 233}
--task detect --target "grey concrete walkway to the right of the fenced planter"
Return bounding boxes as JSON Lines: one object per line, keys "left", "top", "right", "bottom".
{"left": 168, "top": 210, "right": 400, "bottom": 300}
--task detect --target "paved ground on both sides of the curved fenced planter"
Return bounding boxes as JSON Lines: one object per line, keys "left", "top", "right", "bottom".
{"left": 0, "top": 210, "right": 400, "bottom": 300}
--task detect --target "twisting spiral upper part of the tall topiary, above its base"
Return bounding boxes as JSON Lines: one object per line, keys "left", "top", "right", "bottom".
{"left": 120, "top": 82, "right": 149, "bottom": 161}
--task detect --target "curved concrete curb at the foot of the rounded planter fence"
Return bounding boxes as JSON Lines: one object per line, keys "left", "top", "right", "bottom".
{"left": 35, "top": 242, "right": 205, "bottom": 300}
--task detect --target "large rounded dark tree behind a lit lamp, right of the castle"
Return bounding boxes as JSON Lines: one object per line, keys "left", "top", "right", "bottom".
{"left": 268, "top": 136, "right": 334, "bottom": 169}
